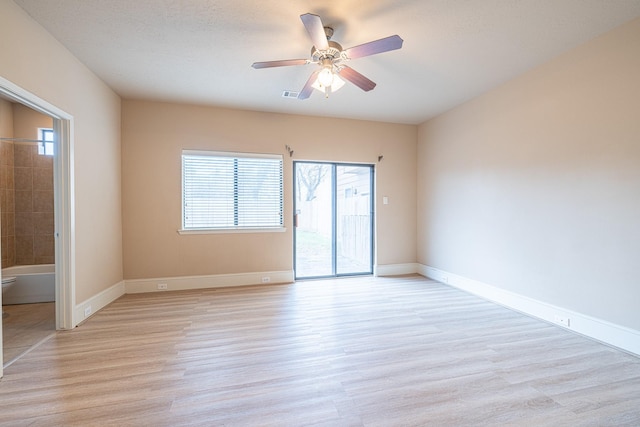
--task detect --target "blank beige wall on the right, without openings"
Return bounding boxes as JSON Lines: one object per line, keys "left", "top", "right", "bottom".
{"left": 418, "top": 19, "right": 640, "bottom": 330}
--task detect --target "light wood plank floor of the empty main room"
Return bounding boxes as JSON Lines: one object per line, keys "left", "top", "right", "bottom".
{"left": 0, "top": 276, "right": 640, "bottom": 426}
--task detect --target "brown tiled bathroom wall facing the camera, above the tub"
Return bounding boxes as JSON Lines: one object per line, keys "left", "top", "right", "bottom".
{"left": 14, "top": 144, "right": 55, "bottom": 265}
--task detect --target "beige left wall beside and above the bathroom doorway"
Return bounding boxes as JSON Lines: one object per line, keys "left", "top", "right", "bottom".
{"left": 0, "top": 0, "right": 123, "bottom": 302}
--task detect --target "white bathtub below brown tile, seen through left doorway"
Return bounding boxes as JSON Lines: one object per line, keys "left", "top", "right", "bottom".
{"left": 2, "top": 264, "right": 56, "bottom": 305}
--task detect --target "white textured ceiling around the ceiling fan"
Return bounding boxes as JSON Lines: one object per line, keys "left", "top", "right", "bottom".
{"left": 15, "top": 0, "right": 640, "bottom": 124}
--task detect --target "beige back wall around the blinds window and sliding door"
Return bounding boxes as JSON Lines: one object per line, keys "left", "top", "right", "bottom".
{"left": 122, "top": 101, "right": 417, "bottom": 279}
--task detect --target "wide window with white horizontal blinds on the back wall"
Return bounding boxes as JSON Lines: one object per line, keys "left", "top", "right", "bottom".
{"left": 182, "top": 150, "right": 284, "bottom": 230}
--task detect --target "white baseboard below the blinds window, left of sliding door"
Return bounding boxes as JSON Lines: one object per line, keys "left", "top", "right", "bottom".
{"left": 125, "top": 271, "right": 294, "bottom": 294}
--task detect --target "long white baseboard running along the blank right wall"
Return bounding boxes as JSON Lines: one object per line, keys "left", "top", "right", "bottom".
{"left": 417, "top": 264, "right": 640, "bottom": 356}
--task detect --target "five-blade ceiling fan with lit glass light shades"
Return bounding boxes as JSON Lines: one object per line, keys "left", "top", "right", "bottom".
{"left": 251, "top": 13, "right": 403, "bottom": 99}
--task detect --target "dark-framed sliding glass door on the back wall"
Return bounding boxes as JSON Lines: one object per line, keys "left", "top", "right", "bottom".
{"left": 293, "top": 161, "right": 374, "bottom": 279}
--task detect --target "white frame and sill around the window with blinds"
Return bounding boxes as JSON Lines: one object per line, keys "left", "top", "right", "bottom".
{"left": 178, "top": 149, "right": 286, "bottom": 234}
